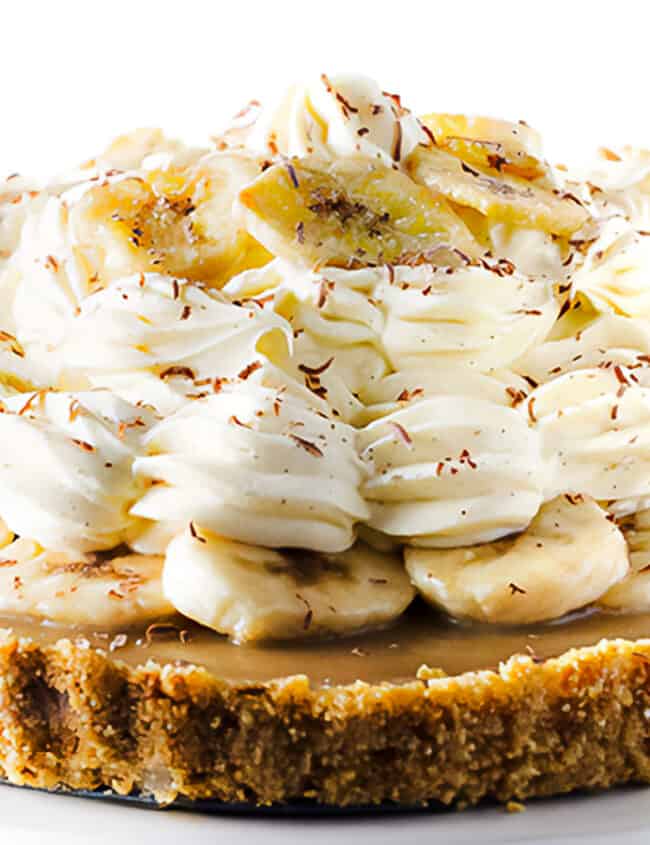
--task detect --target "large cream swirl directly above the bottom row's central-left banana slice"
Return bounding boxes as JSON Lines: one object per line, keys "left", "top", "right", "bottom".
{"left": 131, "top": 380, "right": 368, "bottom": 552}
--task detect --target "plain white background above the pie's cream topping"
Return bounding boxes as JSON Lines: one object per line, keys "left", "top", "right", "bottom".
{"left": 0, "top": 0, "right": 650, "bottom": 175}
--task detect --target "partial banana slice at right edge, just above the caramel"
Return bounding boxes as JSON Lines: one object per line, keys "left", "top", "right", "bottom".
{"left": 598, "top": 508, "right": 650, "bottom": 613}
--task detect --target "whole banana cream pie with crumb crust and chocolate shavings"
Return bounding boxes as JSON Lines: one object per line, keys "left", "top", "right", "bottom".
{"left": 0, "top": 74, "right": 650, "bottom": 806}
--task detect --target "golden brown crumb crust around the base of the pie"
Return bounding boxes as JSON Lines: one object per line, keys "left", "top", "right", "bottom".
{"left": 0, "top": 632, "right": 650, "bottom": 805}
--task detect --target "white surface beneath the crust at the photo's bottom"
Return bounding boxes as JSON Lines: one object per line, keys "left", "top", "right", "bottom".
{"left": 0, "top": 786, "right": 650, "bottom": 845}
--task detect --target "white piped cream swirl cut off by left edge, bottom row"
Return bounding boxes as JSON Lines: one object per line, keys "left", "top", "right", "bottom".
{"left": 0, "top": 391, "right": 152, "bottom": 555}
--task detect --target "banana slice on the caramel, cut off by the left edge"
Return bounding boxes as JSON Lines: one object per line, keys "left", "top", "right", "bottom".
{"left": 0, "top": 538, "right": 174, "bottom": 627}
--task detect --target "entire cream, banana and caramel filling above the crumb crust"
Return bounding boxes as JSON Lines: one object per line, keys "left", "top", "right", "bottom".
{"left": 0, "top": 74, "right": 650, "bottom": 652}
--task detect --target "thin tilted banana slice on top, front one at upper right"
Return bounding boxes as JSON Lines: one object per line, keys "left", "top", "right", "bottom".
{"left": 406, "top": 146, "right": 589, "bottom": 235}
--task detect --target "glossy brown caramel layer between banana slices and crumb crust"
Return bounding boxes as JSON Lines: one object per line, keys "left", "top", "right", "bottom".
{"left": 0, "top": 603, "right": 650, "bottom": 684}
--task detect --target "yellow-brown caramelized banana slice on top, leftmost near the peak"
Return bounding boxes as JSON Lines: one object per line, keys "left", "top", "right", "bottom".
{"left": 70, "top": 153, "right": 271, "bottom": 286}
